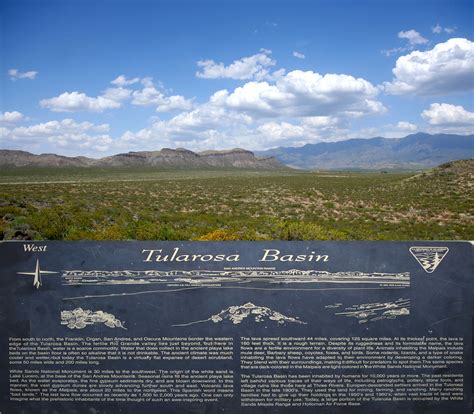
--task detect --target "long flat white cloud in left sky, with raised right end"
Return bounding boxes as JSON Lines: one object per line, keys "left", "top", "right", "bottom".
{"left": 40, "top": 87, "right": 132, "bottom": 112}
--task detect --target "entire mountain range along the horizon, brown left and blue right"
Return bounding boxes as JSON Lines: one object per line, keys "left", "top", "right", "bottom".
{"left": 0, "top": 133, "right": 474, "bottom": 170}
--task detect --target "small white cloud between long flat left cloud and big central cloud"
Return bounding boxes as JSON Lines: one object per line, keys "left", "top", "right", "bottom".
{"left": 132, "top": 78, "right": 193, "bottom": 112}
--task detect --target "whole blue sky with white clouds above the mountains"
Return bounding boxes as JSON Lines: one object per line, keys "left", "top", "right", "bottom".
{"left": 0, "top": 0, "right": 474, "bottom": 158}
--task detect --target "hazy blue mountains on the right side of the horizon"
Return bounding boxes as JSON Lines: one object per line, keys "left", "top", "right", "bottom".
{"left": 256, "top": 133, "right": 474, "bottom": 170}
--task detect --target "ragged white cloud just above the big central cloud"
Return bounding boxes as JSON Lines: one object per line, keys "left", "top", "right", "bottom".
{"left": 196, "top": 49, "right": 276, "bottom": 80}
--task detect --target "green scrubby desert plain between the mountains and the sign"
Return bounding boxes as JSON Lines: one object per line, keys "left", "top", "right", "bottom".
{"left": 0, "top": 160, "right": 474, "bottom": 240}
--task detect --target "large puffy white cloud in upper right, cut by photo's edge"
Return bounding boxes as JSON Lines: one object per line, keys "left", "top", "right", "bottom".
{"left": 384, "top": 38, "right": 474, "bottom": 95}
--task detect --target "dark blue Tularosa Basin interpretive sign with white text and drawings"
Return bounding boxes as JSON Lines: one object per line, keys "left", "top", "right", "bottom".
{"left": 0, "top": 241, "right": 474, "bottom": 414}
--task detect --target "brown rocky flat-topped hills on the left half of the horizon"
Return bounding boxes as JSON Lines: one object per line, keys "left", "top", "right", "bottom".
{"left": 0, "top": 148, "right": 287, "bottom": 170}
